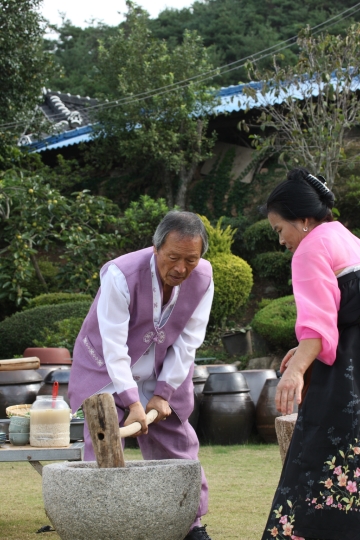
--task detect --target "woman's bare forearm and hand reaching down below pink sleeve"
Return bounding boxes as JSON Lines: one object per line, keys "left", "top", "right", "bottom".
{"left": 275, "top": 338, "right": 322, "bottom": 414}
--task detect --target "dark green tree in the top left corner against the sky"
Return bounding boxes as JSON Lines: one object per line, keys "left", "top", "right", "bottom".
{"left": 0, "top": 0, "right": 52, "bottom": 148}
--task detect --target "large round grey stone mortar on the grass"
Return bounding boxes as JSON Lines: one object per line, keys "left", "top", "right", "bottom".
{"left": 42, "top": 459, "right": 201, "bottom": 540}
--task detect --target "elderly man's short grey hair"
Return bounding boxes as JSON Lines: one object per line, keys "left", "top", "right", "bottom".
{"left": 153, "top": 210, "right": 209, "bottom": 256}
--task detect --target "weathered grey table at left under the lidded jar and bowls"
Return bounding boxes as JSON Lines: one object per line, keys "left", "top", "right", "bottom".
{"left": 0, "top": 442, "right": 85, "bottom": 475}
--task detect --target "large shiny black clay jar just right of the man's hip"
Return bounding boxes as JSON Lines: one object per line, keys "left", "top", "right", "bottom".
{"left": 198, "top": 372, "right": 255, "bottom": 445}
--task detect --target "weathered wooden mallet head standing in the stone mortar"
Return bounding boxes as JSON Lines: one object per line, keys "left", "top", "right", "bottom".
{"left": 83, "top": 394, "right": 125, "bottom": 468}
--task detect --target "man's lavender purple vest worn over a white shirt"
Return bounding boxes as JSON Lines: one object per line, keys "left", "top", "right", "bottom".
{"left": 69, "top": 247, "right": 212, "bottom": 421}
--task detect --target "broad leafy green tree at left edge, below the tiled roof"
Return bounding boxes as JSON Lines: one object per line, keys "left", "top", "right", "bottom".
{"left": 0, "top": 169, "right": 122, "bottom": 306}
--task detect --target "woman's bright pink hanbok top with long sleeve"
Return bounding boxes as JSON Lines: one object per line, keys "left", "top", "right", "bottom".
{"left": 292, "top": 221, "right": 360, "bottom": 365}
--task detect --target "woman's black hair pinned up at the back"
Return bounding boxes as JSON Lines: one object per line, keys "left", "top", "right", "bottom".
{"left": 261, "top": 167, "right": 335, "bottom": 222}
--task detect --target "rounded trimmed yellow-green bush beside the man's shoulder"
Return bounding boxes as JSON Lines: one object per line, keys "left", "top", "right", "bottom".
{"left": 210, "top": 253, "right": 253, "bottom": 326}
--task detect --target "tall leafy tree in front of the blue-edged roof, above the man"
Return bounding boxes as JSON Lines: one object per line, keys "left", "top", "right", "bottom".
{"left": 91, "top": 1, "right": 217, "bottom": 208}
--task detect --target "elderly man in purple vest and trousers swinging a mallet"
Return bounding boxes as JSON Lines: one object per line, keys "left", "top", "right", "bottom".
{"left": 69, "top": 211, "right": 214, "bottom": 540}
